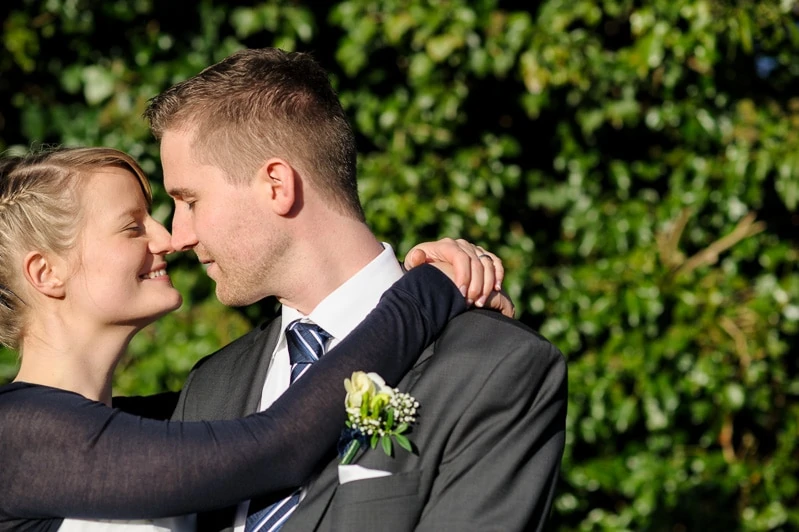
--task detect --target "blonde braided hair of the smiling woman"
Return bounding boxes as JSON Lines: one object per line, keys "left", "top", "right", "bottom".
{"left": 0, "top": 148, "right": 152, "bottom": 349}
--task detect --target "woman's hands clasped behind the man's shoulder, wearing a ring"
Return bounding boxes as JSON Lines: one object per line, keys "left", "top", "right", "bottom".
{"left": 405, "top": 238, "right": 515, "bottom": 318}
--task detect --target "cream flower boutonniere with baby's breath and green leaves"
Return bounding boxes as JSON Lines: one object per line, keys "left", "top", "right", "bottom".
{"left": 338, "top": 371, "right": 419, "bottom": 465}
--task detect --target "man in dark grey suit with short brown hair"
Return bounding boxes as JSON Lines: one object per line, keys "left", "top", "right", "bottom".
{"left": 146, "top": 49, "right": 566, "bottom": 532}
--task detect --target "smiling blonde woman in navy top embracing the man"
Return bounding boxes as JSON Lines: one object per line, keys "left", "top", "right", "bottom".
{"left": 0, "top": 148, "right": 510, "bottom": 530}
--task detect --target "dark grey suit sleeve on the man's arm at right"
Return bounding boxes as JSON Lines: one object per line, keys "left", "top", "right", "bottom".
{"left": 416, "top": 332, "right": 567, "bottom": 532}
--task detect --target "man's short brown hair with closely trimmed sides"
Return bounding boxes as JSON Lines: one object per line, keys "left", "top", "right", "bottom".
{"left": 144, "top": 48, "right": 364, "bottom": 221}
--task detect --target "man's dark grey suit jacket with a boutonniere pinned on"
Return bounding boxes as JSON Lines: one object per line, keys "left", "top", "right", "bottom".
{"left": 176, "top": 311, "right": 566, "bottom": 532}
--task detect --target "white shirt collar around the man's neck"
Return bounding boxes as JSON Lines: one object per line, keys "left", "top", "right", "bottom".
{"left": 281, "top": 242, "right": 402, "bottom": 340}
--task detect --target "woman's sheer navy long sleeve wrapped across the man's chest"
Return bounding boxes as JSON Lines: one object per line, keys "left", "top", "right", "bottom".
{"left": 0, "top": 266, "right": 465, "bottom": 529}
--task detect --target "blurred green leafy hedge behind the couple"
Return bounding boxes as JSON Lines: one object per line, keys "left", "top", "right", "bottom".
{"left": 0, "top": 0, "right": 799, "bottom": 530}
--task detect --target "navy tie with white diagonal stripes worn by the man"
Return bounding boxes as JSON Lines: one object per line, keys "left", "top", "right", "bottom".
{"left": 244, "top": 320, "right": 330, "bottom": 532}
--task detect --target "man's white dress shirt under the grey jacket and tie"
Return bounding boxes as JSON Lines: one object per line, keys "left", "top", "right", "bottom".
{"left": 235, "top": 242, "right": 402, "bottom": 532}
